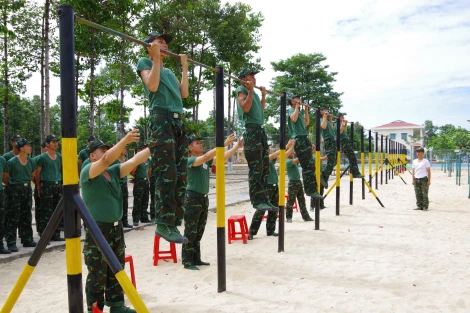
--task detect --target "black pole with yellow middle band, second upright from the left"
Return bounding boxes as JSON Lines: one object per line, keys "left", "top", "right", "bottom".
{"left": 215, "top": 66, "right": 227, "bottom": 292}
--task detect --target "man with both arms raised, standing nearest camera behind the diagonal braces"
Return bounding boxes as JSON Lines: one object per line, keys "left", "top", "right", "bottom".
{"left": 80, "top": 130, "right": 150, "bottom": 313}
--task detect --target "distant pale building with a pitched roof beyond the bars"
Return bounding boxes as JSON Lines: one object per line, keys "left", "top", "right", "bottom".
{"left": 372, "top": 120, "right": 425, "bottom": 161}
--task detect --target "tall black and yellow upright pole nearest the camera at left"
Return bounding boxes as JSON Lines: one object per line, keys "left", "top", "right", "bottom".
{"left": 58, "top": 4, "right": 83, "bottom": 313}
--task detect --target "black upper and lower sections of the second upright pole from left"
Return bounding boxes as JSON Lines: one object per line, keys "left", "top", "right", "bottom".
{"left": 215, "top": 66, "right": 227, "bottom": 292}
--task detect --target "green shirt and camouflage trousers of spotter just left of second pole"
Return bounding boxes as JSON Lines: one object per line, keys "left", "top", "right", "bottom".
{"left": 181, "top": 156, "right": 213, "bottom": 267}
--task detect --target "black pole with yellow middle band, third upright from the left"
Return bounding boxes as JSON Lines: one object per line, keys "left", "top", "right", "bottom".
{"left": 277, "top": 92, "right": 286, "bottom": 252}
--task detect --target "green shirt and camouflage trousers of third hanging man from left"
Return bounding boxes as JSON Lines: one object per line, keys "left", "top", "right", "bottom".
{"left": 287, "top": 107, "right": 318, "bottom": 196}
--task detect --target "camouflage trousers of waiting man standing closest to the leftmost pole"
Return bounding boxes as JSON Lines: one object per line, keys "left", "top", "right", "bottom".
{"left": 36, "top": 182, "right": 62, "bottom": 238}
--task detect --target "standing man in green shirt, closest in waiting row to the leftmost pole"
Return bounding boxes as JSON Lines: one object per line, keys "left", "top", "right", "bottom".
{"left": 35, "top": 134, "right": 65, "bottom": 241}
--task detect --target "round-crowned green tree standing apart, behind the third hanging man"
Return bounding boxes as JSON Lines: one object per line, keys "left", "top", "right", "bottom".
{"left": 265, "top": 53, "right": 342, "bottom": 131}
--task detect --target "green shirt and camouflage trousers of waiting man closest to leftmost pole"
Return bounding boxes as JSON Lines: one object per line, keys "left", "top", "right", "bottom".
{"left": 36, "top": 152, "right": 62, "bottom": 240}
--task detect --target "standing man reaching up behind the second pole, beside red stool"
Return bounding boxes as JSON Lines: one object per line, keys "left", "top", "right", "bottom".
{"left": 181, "top": 135, "right": 243, "bottom": 270}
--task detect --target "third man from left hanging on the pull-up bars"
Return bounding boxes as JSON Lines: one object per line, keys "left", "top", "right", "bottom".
{"left": 287, "top": 96, "right": 322, "bottom": 198}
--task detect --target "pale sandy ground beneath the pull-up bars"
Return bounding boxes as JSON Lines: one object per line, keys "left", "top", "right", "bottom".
{"left": 0, "top": 170, "right": 470, "bottom": 313}
